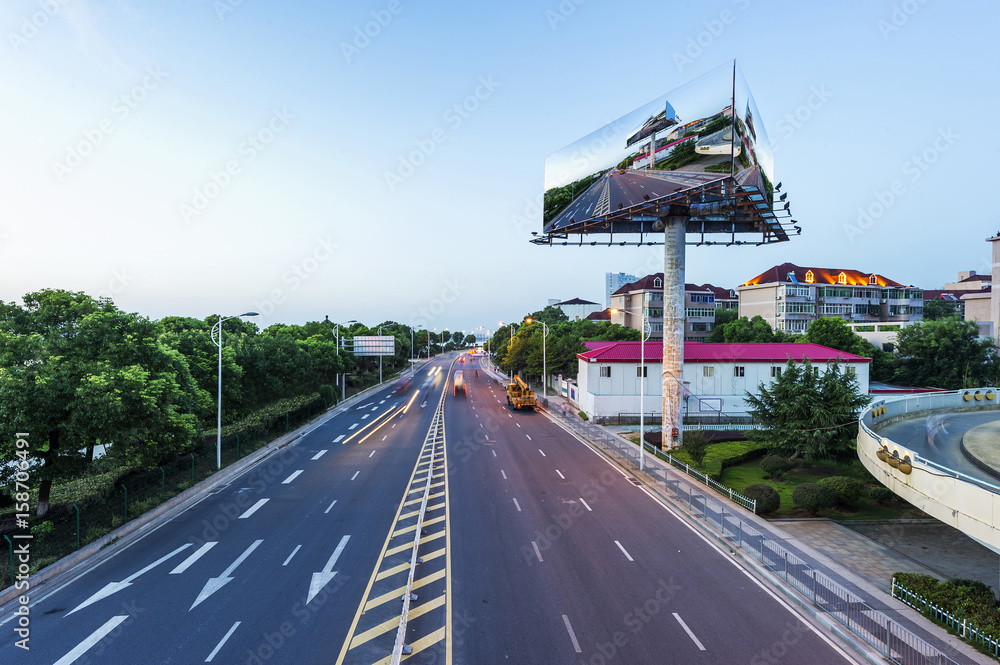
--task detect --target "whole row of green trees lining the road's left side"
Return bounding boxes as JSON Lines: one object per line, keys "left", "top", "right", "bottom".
{"left": 0, "top": 289, "right": 475, "bottom": 514}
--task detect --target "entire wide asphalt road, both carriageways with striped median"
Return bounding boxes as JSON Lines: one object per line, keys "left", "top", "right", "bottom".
{"left": 0, "top": 357, "right": 853, "bottom": 665}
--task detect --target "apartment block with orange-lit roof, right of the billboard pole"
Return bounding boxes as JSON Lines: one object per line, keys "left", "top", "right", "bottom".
{"left": 737, "top": 263, "right": 924, "bottom": 333}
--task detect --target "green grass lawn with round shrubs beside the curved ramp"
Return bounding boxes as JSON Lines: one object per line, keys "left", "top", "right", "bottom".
{"left": 722, "top": 460, "right": 928, "bottom": 520}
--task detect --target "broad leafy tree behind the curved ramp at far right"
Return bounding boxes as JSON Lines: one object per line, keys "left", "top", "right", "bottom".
{"left": 893, "top": 317, "right": 998, "bottom": 390}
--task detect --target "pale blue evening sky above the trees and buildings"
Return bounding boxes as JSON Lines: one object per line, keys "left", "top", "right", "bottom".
{"left": 0, "top": 0, "right": 1000, "bottom": 332}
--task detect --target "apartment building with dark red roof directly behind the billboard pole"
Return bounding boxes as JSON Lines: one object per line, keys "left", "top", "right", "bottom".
{"left": 611, "top": 272, "right": 739, "bottom": 341}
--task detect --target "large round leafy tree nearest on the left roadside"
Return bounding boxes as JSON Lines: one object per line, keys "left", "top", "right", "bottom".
{"left": 0, "top": 289, "right": 211, "bottom": 515}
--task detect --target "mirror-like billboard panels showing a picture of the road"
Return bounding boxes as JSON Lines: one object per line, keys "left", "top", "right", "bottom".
{"left": 543, "top": 61, "right": 773, "bottom": 233}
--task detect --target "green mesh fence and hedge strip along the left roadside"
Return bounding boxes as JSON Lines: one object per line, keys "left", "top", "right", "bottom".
{"left": 0, "top": 400, "right": 325, "bottom": 590}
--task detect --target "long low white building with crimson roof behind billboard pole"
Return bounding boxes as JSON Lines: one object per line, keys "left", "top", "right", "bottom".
{"left": 576, "top": 341, "right": 871, "bottom": 418}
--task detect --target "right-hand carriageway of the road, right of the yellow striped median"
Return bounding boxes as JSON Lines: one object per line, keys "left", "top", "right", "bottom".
{"left": 446, "top": 364, "right": 852, "bottom": 663}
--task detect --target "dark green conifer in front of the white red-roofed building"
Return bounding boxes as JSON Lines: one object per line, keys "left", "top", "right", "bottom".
{"left": 746, "top": 360, "right": 871, "bottom": 459}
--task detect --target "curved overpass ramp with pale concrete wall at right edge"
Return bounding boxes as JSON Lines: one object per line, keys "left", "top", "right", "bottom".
{"left": 858, "top": 388, "right": 1000, "bottom": 552}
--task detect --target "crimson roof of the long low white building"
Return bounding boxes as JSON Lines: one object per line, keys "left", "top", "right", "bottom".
{"left": 576, "top": 341, "right": 872, "bottom": 363}
